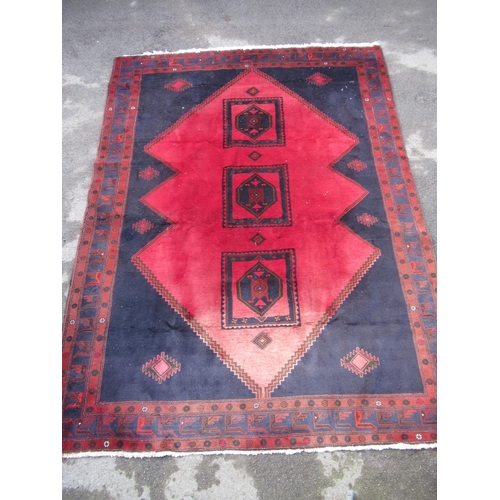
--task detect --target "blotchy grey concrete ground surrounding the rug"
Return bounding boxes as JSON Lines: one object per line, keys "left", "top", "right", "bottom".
{"left": 62, "top": 0, "right": 437, "bottom": 500}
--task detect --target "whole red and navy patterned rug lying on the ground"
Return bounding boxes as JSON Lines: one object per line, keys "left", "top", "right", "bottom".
{"left": 62, "top": 45, "right": 437, "bottom": 456}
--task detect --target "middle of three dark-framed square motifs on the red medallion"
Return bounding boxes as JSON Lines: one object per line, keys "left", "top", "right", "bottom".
{"left": 223, "top": 165, "right": 292, "bottom": 227}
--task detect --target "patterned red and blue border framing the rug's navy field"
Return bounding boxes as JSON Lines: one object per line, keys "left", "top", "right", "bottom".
{"left": 62, "top": 46, "right": 437, "bottom": 454}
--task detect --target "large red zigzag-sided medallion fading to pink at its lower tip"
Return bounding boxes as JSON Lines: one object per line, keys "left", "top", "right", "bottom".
{"left": 137, "top": 68, "right": 380, "bottom": 397}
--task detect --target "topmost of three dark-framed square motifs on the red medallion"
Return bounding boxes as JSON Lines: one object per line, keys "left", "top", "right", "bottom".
{"left": 223, "top": 97, "right": 285, "bottom": 148}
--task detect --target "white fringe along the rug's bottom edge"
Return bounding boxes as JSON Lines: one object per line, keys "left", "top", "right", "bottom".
{"left": 62, "top": 443, "right": 437, "bottom": 458}
